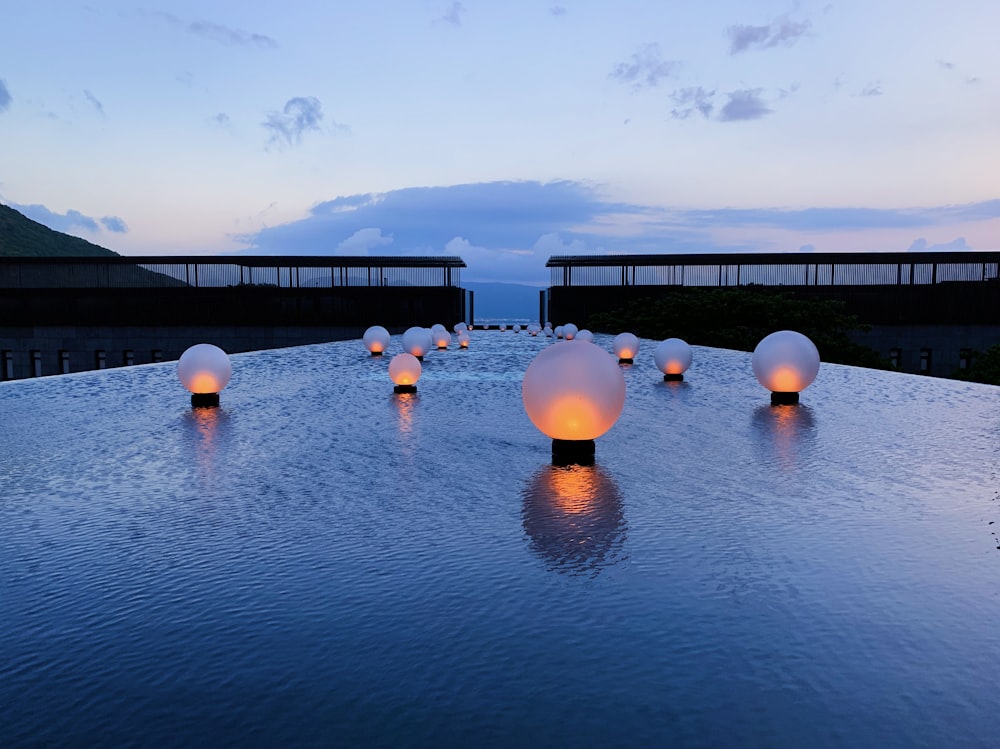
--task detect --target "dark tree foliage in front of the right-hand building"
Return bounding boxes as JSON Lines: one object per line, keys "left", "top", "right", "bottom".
{"left": 589, "top": 287, "right": 890, "bottom": 369}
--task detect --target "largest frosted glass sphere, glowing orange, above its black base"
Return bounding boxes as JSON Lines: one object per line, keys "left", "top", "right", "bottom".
{"left": 521, "top": 341, "right": 625, "bottom": 440}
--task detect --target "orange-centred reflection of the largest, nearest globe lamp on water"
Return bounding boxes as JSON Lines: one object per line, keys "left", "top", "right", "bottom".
{"left": 521, "top": 462, "right": 627, "bottom": 576}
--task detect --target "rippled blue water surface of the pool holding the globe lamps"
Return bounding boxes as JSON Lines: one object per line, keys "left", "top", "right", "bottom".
{"left": 0, "top": 331, "right": 1000, "bottom": 747}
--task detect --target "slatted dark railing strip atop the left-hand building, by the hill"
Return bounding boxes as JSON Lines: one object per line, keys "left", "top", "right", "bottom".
{"left": 0, "top": 256, "right": 466, "bottom": 289}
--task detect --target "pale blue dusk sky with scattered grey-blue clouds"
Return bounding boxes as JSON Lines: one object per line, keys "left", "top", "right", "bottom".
{"left": 0, "top": 0, "right": 1000, "bottom": 284}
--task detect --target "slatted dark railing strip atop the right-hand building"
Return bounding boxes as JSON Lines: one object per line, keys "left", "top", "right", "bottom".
{"left": 545, "top": 252, "right": 1000, "bottom": 286}
